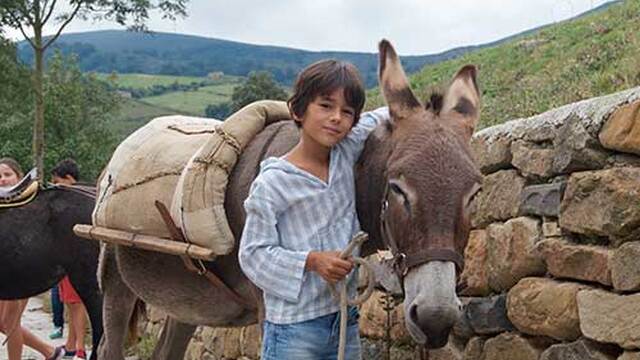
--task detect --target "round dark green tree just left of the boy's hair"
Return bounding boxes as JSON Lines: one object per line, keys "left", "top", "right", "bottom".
{"left": 230, "top": 71, "right": 287, "bottom": 113}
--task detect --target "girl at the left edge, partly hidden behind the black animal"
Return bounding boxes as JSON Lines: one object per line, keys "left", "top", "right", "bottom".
{"left": 0, "top": 158, "right": 64, "bottom": 360}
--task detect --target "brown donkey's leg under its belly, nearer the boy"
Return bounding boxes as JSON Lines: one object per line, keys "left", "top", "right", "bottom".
{"left": 151, "top": 316, "right": 196, "bottom": 360}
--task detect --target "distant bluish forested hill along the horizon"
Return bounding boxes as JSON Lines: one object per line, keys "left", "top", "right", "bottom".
{"left": 18, "top": 30, "right": 504, "bottom": 87}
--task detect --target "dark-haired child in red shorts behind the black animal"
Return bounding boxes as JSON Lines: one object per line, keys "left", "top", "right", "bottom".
{"left": 51, "top": 159, "right": 87, "bottom": 359}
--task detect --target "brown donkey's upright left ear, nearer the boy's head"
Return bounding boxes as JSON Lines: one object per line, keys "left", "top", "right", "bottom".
{"left": 378, "top": 40, "right": 422, "bottom": 122}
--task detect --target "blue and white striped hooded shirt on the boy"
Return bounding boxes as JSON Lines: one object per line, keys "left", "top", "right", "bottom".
{"left": 238, "top": 108, "right": 389, "bottom": 324}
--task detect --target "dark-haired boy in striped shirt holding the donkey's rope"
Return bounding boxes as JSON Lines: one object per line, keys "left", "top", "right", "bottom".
{"left": 239, "top": 60, "right": 389, "bottom": 360}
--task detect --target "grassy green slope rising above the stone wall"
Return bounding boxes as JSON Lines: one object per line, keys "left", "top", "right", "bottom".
{"left": 367, "top": 0, "right": 640, "bottom": 128}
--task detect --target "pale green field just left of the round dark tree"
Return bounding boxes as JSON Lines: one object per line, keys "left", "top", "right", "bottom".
{"left": 140, "top": 82, "right": 238, "bottom": 116}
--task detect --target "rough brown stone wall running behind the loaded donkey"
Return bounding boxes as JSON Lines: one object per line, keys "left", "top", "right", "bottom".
{"left": 140, "top": 88, "right": 640, "bottom": 360}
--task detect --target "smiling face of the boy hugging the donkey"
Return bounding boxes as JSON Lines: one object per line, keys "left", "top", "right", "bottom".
{"left": 295, "top": 88, "right": 355, "bottom": 148}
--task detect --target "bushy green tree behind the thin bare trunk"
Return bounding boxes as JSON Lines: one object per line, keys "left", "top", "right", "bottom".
{"left": 0, "top": 53, "right": 121, "bottom": 181}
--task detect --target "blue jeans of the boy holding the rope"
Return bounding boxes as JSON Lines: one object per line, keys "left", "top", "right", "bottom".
{"left": 261, "top": 307, "right": 361, "bottom": 360}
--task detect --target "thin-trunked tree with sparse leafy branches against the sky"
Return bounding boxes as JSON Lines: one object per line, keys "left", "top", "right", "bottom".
{"left": 0, "top": 0, "right": 188, "bottom": 176}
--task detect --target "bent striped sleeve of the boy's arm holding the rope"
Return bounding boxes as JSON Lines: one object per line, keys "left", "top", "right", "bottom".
{"left": 238, "top": 182, "right": 309, "bottom": 302}
